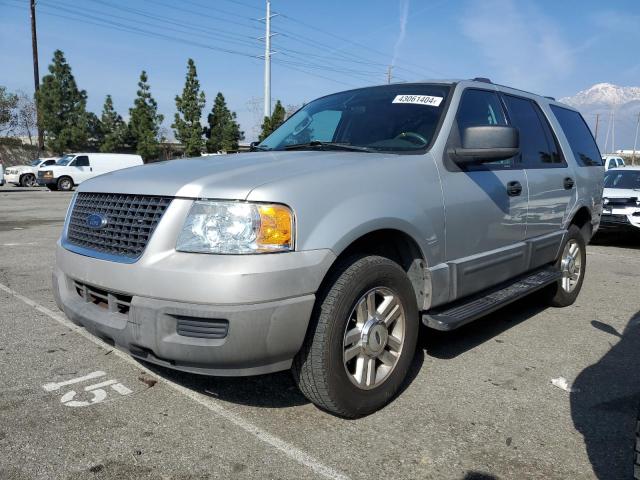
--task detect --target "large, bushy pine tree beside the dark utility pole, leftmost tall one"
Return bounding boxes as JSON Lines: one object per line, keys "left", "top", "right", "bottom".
{"left": 37, "top": 50, "right": 91, "bottom": 154}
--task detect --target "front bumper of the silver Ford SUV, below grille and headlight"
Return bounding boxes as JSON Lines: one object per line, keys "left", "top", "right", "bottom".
{"left": 53, "top": 245, "right": 335, "bottom": 376}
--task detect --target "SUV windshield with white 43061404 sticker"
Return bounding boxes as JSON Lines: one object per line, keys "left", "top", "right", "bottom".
{"left": 258, "top": 84, "right": 450, "bottom": 153}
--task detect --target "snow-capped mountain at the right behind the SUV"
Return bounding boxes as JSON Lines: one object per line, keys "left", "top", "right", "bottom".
{"left": 560, "top": 83, "right": 640, "bottom": 153}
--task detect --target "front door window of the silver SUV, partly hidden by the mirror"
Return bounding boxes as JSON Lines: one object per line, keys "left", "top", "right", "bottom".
{"left": 454, "top": 89, "right": 512, "bottom": 170}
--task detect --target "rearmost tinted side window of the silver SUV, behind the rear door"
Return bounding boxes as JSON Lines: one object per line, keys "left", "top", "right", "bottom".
{"left": 551, "top": 105, "right": 603, "bottom": 167}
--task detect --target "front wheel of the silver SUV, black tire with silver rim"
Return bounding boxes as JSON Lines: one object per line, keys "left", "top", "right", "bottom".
{"left": 292, "top": 255, "right": 419, "bottom": 418}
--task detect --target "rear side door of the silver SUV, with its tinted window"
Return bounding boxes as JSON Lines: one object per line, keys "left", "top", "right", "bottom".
{"left": 503, "top": 95, "right": 576, "bottom": 268}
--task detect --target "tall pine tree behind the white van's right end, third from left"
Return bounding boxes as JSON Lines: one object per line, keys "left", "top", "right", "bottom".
{"left": 129, "top": 70, "right": 164, "bottom": 161}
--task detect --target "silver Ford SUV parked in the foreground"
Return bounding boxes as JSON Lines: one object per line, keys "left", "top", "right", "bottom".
{"left": 53, "top": 79, "right": 603, "bottom": 417}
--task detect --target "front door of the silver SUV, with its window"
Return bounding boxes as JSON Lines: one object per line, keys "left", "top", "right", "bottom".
{"left": 442, "top": 88, "right": 528, "bottom": 300}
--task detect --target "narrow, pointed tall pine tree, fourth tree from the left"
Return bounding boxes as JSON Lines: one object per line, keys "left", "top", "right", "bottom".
{"left": 171, "top": 58, "right": 205, "bottom": 157}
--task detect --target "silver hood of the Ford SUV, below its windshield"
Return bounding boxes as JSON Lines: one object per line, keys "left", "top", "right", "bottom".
{"left": 78, "top": 151, "right": 383, "bottom": 201}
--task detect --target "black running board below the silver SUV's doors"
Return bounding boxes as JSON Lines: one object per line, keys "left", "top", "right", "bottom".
{"left": 422, "top": 267, "right": 562, "bottom": 331}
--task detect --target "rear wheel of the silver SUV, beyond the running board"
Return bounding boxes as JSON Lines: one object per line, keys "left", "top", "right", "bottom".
{"left": 549, "top": 225, "right": 587, "bottom": 307}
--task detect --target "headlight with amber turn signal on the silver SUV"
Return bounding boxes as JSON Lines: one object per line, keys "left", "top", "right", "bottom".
{"left": 176, "top": 200, "right": 293, "bottom": 254}
